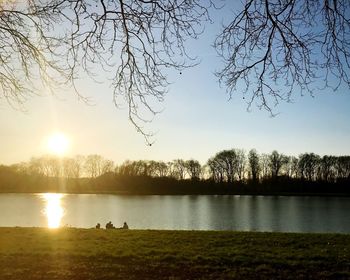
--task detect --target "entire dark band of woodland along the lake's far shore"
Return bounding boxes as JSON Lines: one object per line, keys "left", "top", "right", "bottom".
{"left": 0, "top": 149, "right": 350, "bottom": 195}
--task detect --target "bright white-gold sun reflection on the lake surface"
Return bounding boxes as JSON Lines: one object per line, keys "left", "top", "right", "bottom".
{"left": 41, "top": 193, "right": 64, "bottom": 228}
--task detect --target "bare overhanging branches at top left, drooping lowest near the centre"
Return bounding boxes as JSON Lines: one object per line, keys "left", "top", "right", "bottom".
{"left": 0, "top": 0, "right": 212, "bottom": 142}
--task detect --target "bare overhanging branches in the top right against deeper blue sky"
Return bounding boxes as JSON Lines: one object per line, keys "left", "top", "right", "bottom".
{"left": 215, "top": 0, "right": 350, "bottom": 113}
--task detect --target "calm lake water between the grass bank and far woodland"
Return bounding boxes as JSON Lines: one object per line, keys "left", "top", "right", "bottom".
{"left": 0, "top": 194, "right": 350, "bottom": 233}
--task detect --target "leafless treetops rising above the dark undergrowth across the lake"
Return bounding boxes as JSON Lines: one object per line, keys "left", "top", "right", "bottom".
{"left": 3, "top": 149, "right": 350, "bottom": 183}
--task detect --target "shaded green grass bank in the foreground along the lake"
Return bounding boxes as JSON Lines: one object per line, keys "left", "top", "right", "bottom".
{"left": 0, "top": 228, "right": 350, "bottom": 280}
